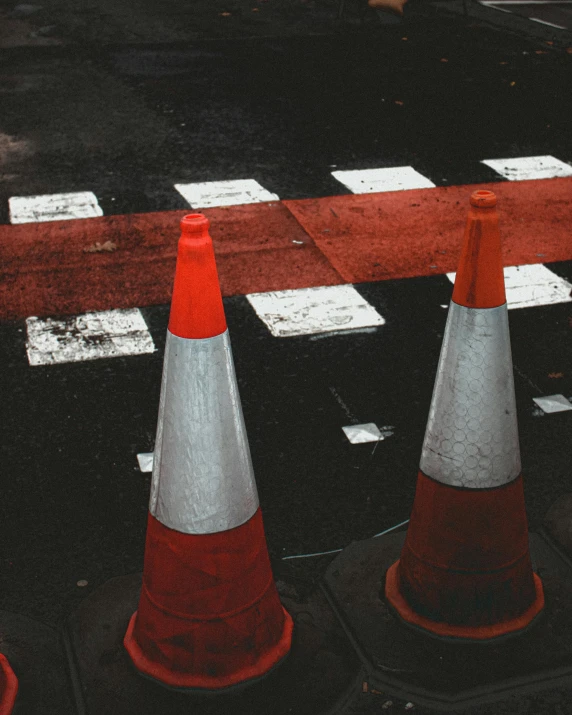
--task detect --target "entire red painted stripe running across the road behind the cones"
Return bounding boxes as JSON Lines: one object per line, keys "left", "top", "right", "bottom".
{"left": 0, "top": 178, "right": 572, "bottom": 319}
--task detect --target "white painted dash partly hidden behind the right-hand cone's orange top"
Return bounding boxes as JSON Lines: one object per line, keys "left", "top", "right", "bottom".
{"left": 447, "top": 263, "right": 572, "bottom": 310}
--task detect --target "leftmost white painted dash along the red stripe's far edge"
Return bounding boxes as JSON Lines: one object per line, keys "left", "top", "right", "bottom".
{"left": 8, "top": 191, "right": 103, "bottom": 223}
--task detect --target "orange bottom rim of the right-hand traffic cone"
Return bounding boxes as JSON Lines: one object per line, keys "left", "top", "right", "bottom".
{"left": 385, "top": 561, "right": 544, "bottom": 642}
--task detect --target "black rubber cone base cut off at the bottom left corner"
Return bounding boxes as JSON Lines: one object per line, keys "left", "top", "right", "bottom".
{"left": 0, "top": 611, "right": 75, "bottom": 715}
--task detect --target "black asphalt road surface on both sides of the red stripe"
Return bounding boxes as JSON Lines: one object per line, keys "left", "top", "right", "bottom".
{"left": 0, "top": 0, "right": 572, "bottom": 712}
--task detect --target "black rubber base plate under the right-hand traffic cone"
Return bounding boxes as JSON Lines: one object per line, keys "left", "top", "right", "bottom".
{"left": 324, "top": 533, "right": 572, "bottom": 713}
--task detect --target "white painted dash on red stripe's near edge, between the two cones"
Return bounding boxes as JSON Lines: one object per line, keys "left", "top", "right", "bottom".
{"left": 246, "top": 285, "right": 385, "bottom": 338}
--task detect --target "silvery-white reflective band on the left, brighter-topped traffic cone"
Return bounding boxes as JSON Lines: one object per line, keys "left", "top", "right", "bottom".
{"left": 149, "top": 331, "right": 258, "bottom": 534}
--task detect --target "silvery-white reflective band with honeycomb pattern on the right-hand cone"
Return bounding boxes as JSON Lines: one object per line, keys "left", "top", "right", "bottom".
{"left": 419, "top": 302, "right": 521, "bottom": 489}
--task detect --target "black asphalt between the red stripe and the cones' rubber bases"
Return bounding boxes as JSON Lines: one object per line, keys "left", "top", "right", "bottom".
{"left": 0, "top": 262, "right": 572, "bottom": 624}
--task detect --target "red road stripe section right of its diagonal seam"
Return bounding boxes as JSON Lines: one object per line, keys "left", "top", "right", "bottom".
{"left": 284, "top": 178, "right": 572, "bottom": 283}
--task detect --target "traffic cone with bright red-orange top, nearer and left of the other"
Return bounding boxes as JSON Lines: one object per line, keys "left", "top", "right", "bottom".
{"left": 124, "top": 214, "right": 292, "bottom": 691}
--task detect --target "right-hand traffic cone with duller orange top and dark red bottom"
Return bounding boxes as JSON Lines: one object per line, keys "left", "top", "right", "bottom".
{"left": 385, "top": 191, "right": 544, "bottom": 641}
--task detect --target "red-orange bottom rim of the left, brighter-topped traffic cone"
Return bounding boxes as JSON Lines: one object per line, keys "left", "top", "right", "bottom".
{"left": 123, "top": 608, "right": 294, "bottom": 694}
